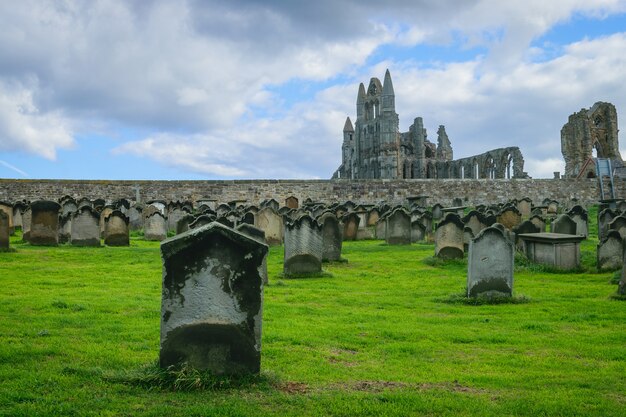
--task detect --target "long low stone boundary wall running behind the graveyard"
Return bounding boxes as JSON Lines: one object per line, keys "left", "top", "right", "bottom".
{"left": 0, "top": 178, "right": 626, "bottom": 206}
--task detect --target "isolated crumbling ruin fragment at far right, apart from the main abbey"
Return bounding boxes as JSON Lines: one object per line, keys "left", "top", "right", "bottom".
{"left": 561, "top": 101, "right": 623, "bottom": 178}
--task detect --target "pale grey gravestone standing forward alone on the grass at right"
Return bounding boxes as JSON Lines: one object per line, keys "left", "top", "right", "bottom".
{"left": 467, "top": 227, "right": 514, "bottom": 297}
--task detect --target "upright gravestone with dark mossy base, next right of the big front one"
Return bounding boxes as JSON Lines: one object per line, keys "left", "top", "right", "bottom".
{"left": 283, "top": 214, "right": 323, "bottom": 277}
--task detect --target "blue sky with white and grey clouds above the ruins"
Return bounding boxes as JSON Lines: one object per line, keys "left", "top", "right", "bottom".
{"left": 0, "top": 0, "right": 626, "bottom": 180}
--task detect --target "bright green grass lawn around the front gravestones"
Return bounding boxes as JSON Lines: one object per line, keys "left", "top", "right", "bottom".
{"left": 0, "top": 219, "right": 626, "bottom": 416}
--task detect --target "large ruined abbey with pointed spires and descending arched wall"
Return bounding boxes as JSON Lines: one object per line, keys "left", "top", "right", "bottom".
{"left": 332, "top": 70, "right": 528, "bottom": 179}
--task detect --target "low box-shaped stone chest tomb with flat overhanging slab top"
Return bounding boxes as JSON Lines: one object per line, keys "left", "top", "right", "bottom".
{"left": 518, "top": 233, "right": 585, "bottom": 269}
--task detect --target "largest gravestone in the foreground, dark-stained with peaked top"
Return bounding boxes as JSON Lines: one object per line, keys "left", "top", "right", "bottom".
{"left": 159, "top": 222, "right": 268, "bottom": 375}
